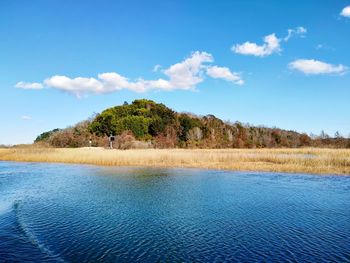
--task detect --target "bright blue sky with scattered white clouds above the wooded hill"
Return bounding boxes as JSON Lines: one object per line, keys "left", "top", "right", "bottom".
{"left": 0, "top": 0, "right": 350, "bottom": 144}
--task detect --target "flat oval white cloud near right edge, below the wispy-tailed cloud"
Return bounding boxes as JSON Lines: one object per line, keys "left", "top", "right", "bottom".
{"left": 289, "top": 59, "right": 348, "bottom": 75}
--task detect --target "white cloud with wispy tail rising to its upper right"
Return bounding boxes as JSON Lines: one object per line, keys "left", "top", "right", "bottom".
{"left": 231, "top": 27, "right": 307, "bottom": 57}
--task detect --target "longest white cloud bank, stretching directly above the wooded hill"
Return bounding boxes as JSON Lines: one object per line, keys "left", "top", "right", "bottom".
{"left": 16, "top": 51, "right": 243, "bottom": 97}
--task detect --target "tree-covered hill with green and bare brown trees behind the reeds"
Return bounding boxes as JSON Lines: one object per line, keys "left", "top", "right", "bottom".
{"left": 35, "top": 99, "right": 350, "bottom": 149}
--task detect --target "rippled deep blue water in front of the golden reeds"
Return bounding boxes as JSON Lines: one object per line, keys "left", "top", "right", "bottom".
{"left": 0, "top": 162, "right": 350, "bottom": 262}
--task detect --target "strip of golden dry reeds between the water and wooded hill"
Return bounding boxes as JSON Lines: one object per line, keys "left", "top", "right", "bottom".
{"left": 0, "top": 147, "right": 350, "bottom": 175}
